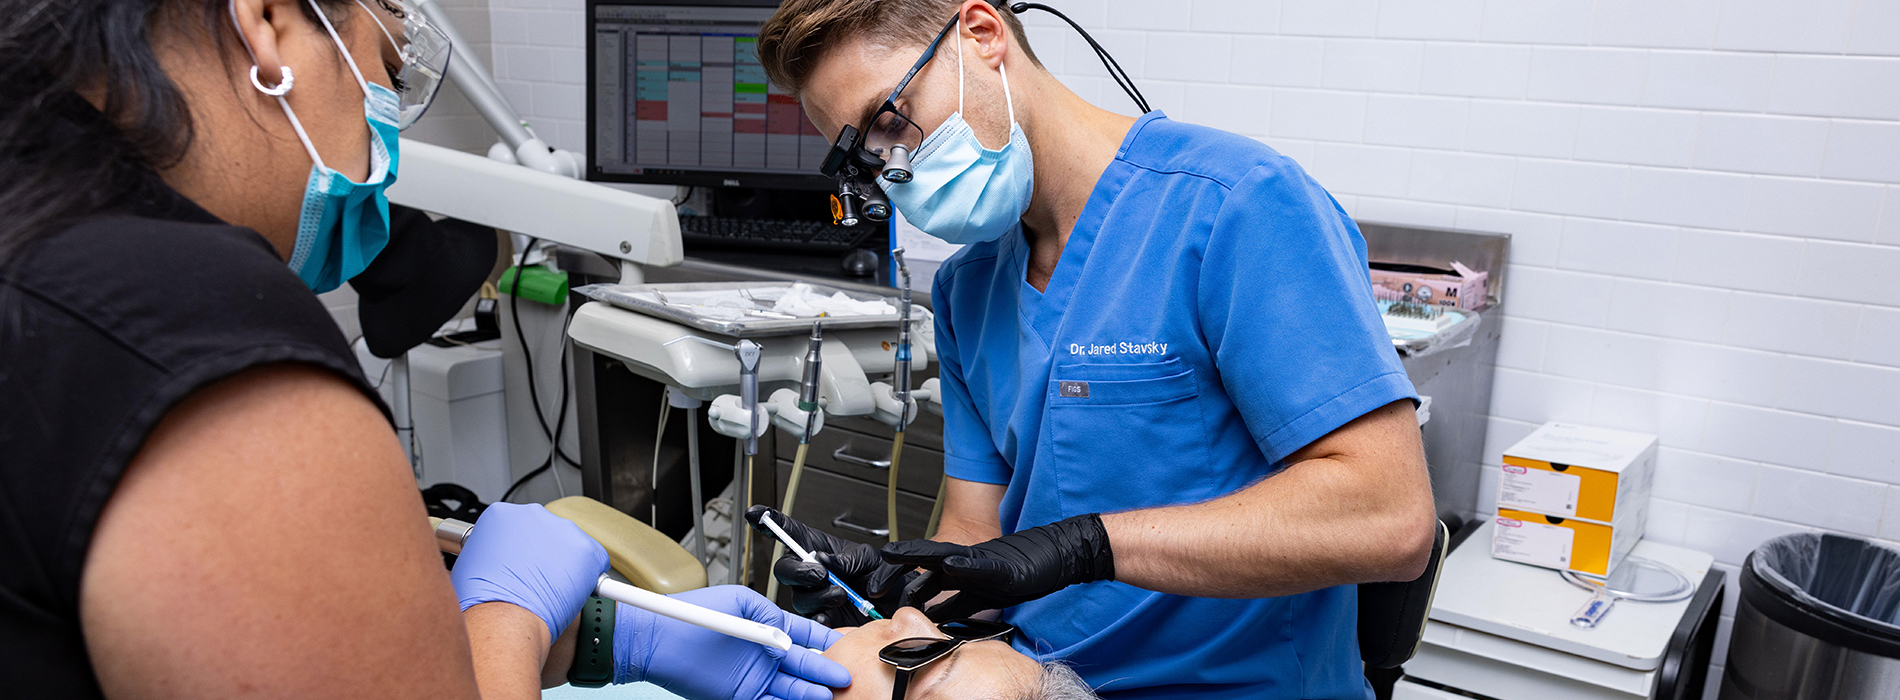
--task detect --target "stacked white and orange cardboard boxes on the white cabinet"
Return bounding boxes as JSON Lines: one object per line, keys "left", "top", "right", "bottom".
{"left": 1492, "top": 422, "right": 1657, "bottom": 576}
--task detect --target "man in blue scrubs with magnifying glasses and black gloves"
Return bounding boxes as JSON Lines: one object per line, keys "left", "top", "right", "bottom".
{"left": 758, "top": 0, "right": 1435, "bottom": 700}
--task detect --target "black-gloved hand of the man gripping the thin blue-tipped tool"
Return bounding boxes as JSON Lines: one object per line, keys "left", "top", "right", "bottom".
{"left": 745, "top": 506, "right": 916, "bottom": 628}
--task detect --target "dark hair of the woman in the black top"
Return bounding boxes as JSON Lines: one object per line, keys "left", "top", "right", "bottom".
{"left": 0, "top": 0, "right": 352, "bottom": 266}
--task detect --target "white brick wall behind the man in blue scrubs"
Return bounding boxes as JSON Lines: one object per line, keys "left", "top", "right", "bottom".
{"left": 431, "top": 0, "right": 1900, "bottom": 687}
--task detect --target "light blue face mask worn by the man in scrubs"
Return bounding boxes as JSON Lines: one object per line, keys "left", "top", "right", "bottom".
{"left": 878, "top": 25, "right": 1036, "bottom": 243}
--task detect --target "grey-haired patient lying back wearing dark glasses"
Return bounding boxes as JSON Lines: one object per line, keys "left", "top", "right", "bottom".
{"left": 825, "top": 607, "right": 1094, "bottom": 700}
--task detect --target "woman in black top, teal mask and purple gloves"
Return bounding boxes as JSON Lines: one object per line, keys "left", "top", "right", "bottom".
{"left": 0, "top": 0, "right": 849, "bottom": 700}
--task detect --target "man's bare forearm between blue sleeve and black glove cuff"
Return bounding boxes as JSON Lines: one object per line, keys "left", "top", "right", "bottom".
{"left": 1102, "top": 399, "right": 1436, "bottom": 597}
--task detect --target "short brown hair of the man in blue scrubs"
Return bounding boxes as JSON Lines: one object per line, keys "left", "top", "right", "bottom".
{"left": 758, "top": 0, "right": 1043, "bottom": 93}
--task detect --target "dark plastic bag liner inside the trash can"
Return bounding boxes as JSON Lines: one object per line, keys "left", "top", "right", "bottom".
{"left": 1742, "top": 533, "right": 1900, "bottom": 658}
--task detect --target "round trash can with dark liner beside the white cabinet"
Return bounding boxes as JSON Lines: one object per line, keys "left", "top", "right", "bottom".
{"left": 1721, "top": 533, "right": 1900, "bottom": 700}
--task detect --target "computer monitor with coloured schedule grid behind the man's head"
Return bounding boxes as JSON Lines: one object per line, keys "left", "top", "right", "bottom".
{"left": 587, "top": 0, "right": 836, "bottom": 190}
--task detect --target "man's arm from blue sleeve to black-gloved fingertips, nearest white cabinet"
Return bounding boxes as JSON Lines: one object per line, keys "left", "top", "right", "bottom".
{"left": 884, "top": 401, "right": 1435, "bottom": 620}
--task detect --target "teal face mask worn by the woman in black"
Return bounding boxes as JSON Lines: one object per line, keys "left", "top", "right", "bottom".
{"left": 232, "top": 2, "right": 401, "bottom": 295}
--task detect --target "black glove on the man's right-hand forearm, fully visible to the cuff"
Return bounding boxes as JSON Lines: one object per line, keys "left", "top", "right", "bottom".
{"left": 884, "top": 514, "right": 1115, "bottom": 622}
